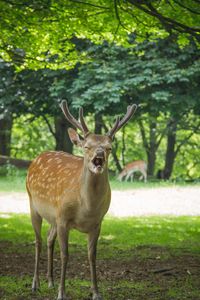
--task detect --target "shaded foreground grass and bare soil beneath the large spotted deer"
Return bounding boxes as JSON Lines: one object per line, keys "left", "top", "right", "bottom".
{"left": 0, "top": 214, "right": 200, "bottom": 300}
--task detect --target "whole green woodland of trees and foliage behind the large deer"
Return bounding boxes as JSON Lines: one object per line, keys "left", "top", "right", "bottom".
{"left": 0, "top": 0, "right": 200, "bottom": 180}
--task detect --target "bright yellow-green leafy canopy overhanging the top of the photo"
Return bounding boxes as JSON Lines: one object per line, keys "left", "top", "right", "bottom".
{"left": 0, "top": 0, "right": 200, "bottom": 69}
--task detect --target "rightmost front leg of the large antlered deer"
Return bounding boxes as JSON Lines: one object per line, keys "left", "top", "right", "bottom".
{"left": 88, "top": 225, "right": 103, "bottom": 300}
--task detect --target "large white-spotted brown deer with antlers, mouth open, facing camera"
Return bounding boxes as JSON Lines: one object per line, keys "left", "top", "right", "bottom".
{"left": 26, "top": 100, "right": 137, "bottom": 300}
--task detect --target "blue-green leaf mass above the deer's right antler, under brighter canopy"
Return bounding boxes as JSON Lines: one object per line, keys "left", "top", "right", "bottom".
{"left": 71, "top": 38, "right": 200, "bottom": 115}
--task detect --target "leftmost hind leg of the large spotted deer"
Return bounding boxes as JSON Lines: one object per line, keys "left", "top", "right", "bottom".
{"left": 31, "top": 208, "right": 42, "bottom": 291}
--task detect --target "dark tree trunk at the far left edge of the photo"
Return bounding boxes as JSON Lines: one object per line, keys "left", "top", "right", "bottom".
{"left": 0, "top": 115, "right": 13, "bottom": 156}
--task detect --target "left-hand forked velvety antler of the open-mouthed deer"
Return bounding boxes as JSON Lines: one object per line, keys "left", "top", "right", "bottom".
{"left": 60, "top": 100, "right": 89, "bottom": 135}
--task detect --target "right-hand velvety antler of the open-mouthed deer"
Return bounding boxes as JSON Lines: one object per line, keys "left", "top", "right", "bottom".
{"left": 107, "top": 104, "right": 137, "bottom": 139}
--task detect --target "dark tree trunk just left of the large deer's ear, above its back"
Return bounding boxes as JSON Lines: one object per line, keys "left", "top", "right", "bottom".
{"left": 54, "top": 116, "right": 73, "bottom": 153}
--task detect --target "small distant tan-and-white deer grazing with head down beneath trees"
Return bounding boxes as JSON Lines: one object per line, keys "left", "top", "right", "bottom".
{"left": 118, "top": 160, "right": 147, "bottom": 182}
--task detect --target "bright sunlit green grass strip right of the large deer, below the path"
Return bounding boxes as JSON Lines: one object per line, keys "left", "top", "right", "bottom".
{"left": 101, "top": 217, "right": 200, "bottom": 252}
